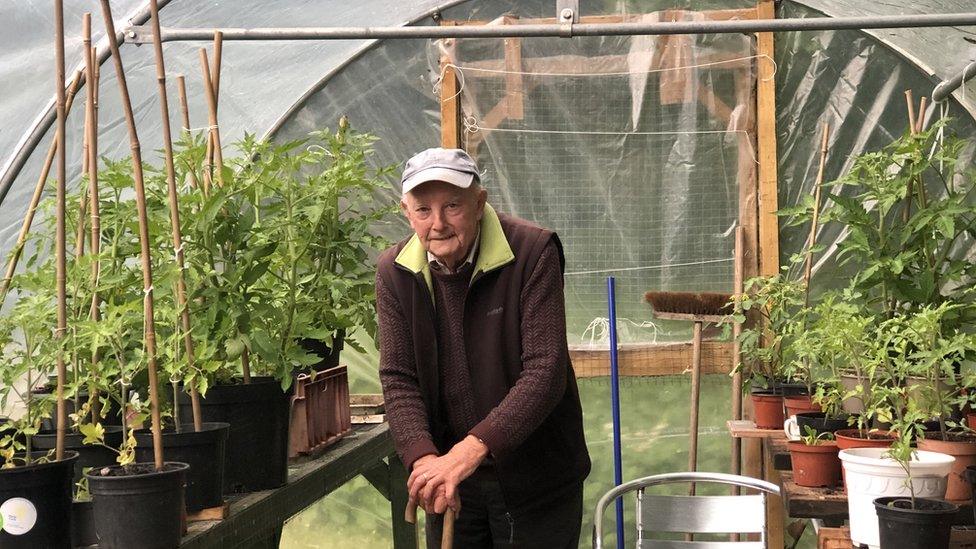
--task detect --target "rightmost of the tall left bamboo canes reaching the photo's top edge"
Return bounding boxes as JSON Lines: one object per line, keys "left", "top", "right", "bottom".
{"left": 149, "top": 0, "right": 203, "bottom": 431}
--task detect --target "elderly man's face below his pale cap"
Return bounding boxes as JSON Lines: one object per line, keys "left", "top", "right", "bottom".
{"left": 400, "top": 181, "right": 488, "bottom": 268}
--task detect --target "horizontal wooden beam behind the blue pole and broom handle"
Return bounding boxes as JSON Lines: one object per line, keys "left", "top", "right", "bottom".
{"left": 569, "top": 341, "right": 732, "bottom": 378}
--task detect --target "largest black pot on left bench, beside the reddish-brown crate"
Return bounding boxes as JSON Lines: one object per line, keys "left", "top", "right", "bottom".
{"left": 180, "top": 377, "right": 290, "bottom": 494}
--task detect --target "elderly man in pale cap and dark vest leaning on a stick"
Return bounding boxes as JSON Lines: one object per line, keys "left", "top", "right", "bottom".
{"left": 376, "top": 149, "right": 590, "bottom": 549}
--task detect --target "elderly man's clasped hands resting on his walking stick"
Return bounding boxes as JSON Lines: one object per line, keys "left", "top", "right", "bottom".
{"left": 407, "top": 435, "right": 488, "bottom": 514}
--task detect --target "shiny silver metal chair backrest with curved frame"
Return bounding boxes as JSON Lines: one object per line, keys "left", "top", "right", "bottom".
{"left": 593, "top": 473, "right": 779, "bottom": 549}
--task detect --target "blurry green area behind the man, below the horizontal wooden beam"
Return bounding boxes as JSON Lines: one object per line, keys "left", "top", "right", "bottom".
{"left": 281, "top": 340, "right": 815, "bottom": 549}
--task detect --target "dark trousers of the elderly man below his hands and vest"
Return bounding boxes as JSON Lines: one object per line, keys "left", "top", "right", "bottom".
{"left": 427, "top": 475, "right": 583, "bottom": 549}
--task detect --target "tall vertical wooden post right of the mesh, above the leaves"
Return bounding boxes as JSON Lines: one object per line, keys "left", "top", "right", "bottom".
{"left": 756, "top": 0, "right": 779, "bottom": 276}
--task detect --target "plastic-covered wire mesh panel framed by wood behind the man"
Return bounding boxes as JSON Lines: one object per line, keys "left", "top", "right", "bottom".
{"left": 442, "top": 28, "right": 762, "bottom": 344}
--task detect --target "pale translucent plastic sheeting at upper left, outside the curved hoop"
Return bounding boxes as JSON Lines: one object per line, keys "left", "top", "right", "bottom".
{"left": 0, "top": 0, "right": 445, "bottom": 251}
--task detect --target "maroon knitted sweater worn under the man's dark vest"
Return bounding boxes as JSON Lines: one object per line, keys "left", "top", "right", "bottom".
{"left": 376, "top": 242, "right": 566, "bottom": 468}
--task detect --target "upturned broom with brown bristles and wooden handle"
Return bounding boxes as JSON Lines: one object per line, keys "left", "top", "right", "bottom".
{"left": 644, "top": 292, "right": 732, "bottom": 496}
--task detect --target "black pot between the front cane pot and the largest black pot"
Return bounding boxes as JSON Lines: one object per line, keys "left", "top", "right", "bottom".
{"left": 136, "top": 423, "right": 230, "bottom": 513}
